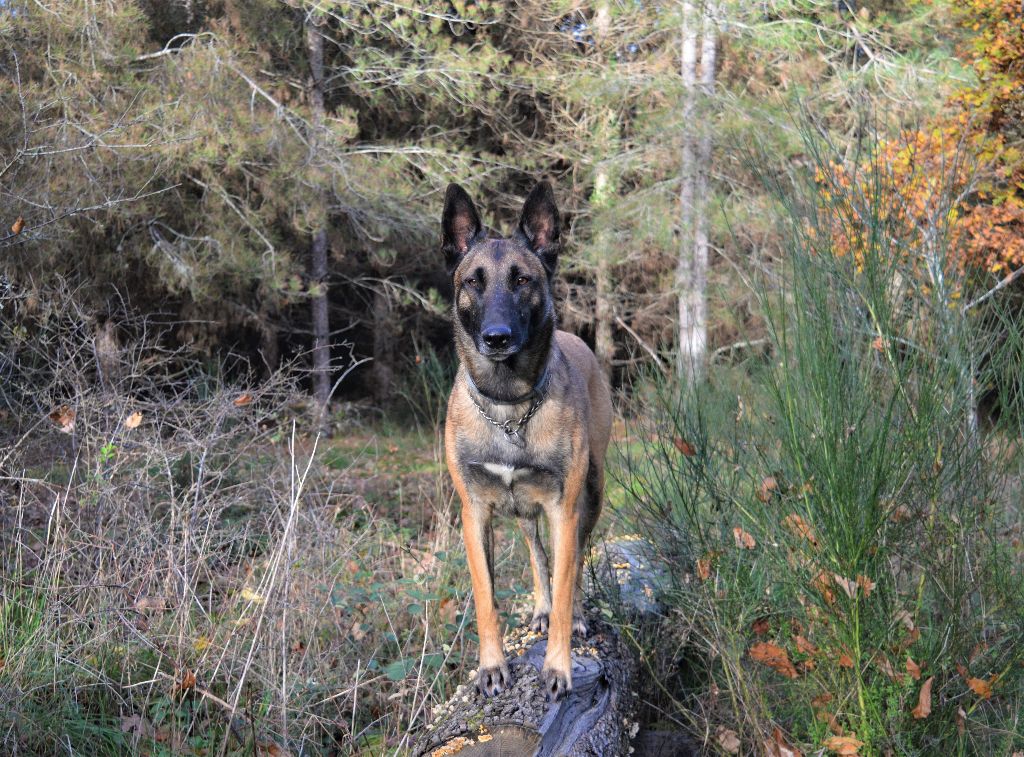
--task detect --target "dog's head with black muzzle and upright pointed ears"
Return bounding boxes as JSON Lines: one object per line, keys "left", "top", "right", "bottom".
{"left": 441, "top": 181, "right": 560, "bottom": 362}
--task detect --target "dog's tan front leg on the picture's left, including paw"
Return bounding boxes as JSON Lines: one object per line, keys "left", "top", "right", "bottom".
{"left": 462, "top": 501, "right": 512, "bottom": 697}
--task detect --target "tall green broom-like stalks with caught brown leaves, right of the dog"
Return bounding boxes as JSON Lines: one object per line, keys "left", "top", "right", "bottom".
{"left": 620, "top": 122, "right": 1024, "bottom": 755}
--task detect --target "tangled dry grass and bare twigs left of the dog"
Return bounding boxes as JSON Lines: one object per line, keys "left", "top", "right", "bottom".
{"left": 0, "top": 280, "right": 548, "bottom": 755}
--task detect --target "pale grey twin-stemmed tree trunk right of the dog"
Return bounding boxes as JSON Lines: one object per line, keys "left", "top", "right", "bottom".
{"left": 676, "top": 2, "right": 718, "bottom": 386}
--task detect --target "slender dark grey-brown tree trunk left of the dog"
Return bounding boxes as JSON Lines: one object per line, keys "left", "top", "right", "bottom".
{"left": 305, "top": 15, "right": 331, "bottom": 431}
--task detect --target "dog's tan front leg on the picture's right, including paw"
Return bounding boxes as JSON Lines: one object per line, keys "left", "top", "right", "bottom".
{"left": 541, "top": 446, "right": 587, "bottom": 702}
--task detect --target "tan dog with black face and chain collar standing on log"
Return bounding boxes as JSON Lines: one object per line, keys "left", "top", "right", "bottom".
{"left": 441, "top": 181, "right": 611, "bottom": 702}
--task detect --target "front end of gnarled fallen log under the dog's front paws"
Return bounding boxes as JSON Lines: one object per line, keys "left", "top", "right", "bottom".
{"left": 413, "top": 609, "right": 638, "bottom": 757}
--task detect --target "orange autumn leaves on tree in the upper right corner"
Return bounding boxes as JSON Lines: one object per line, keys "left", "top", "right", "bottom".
{"left": 812, "top": 0, "right": 1024, "bottom": 278}
